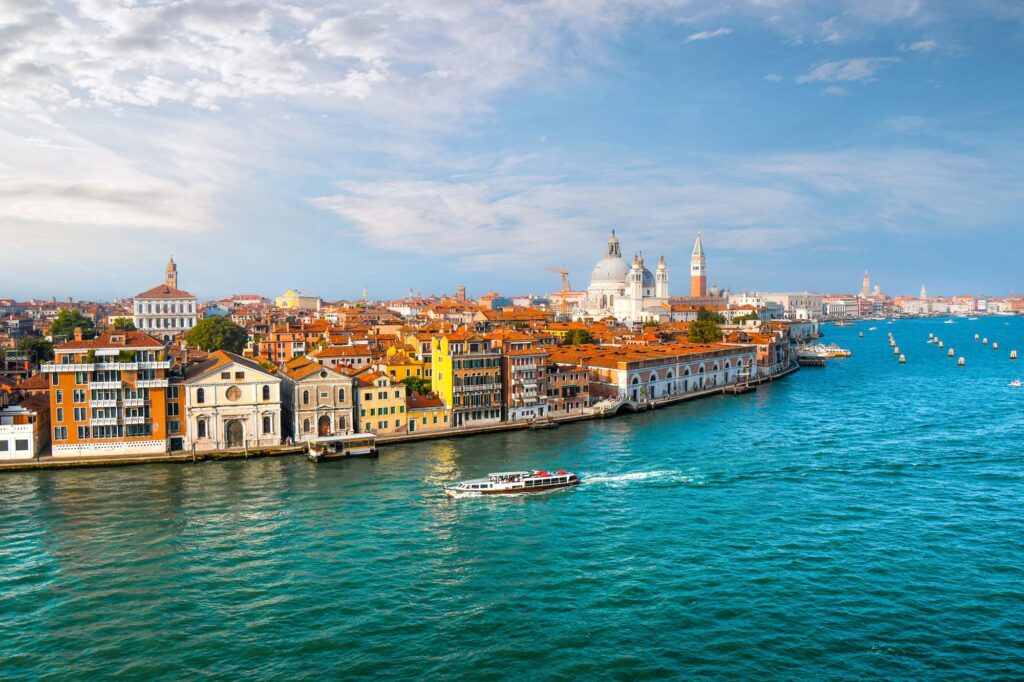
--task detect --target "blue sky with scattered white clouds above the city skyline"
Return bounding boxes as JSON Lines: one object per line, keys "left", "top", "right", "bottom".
{"left": 0, "top": 0, "right": 1024, "bottom": 299}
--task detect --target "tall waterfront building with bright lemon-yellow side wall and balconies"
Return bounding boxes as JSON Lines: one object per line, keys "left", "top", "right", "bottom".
{"left": 430, "top": 332, "right": 502, "bottom": 427}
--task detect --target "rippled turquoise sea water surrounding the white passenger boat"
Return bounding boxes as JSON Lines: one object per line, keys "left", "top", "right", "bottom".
{"left": 0, "top": 318, "right": 1024, "bottom": 680}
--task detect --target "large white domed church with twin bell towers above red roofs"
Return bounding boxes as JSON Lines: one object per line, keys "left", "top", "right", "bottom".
{"left": 585, "top": 230, "right": 669, "bottom": 323}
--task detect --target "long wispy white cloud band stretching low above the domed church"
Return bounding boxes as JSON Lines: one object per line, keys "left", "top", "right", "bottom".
{"left": 313, "top": 145, "right": 1024, "bottom": 271}
